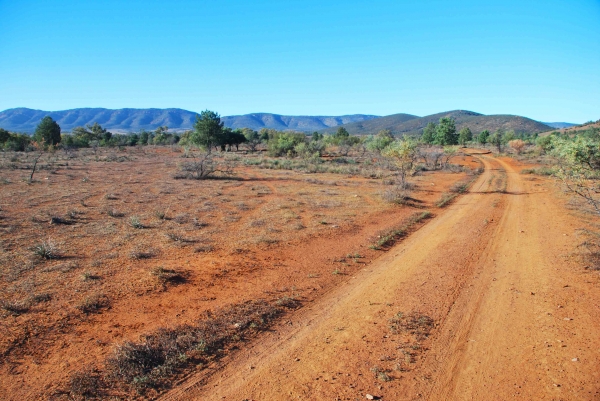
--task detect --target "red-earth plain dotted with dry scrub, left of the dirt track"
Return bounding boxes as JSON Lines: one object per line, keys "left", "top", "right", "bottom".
{"left": 0, "top": 143, "right": 478, "bottom": 399}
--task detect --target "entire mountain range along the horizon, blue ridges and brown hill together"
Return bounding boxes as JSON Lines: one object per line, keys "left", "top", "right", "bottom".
{"left": 0, "top": 108, "right": 570, "bottom": 135}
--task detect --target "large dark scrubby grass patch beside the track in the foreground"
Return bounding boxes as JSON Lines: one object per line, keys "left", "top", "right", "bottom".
{"left": 72, "top": 301, "right": 290, "bottom": 397}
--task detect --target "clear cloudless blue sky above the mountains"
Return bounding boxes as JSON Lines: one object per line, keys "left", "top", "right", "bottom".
{"left": 0, "top": 0, "right": 600, "bottom": 123}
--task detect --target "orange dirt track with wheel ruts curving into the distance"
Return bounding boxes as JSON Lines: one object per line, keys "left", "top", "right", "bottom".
{"left": 163, "top": 156, "right": 600, "bottom": 401}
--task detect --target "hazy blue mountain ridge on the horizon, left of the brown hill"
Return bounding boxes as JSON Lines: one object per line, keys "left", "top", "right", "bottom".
{"left": 0, "top": 108, "right": 377, "bottom": 132}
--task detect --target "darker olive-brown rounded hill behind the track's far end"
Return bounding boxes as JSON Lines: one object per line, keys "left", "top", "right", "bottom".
{"left": 322, "top": 110, "right": 552, "bottom": 135}
